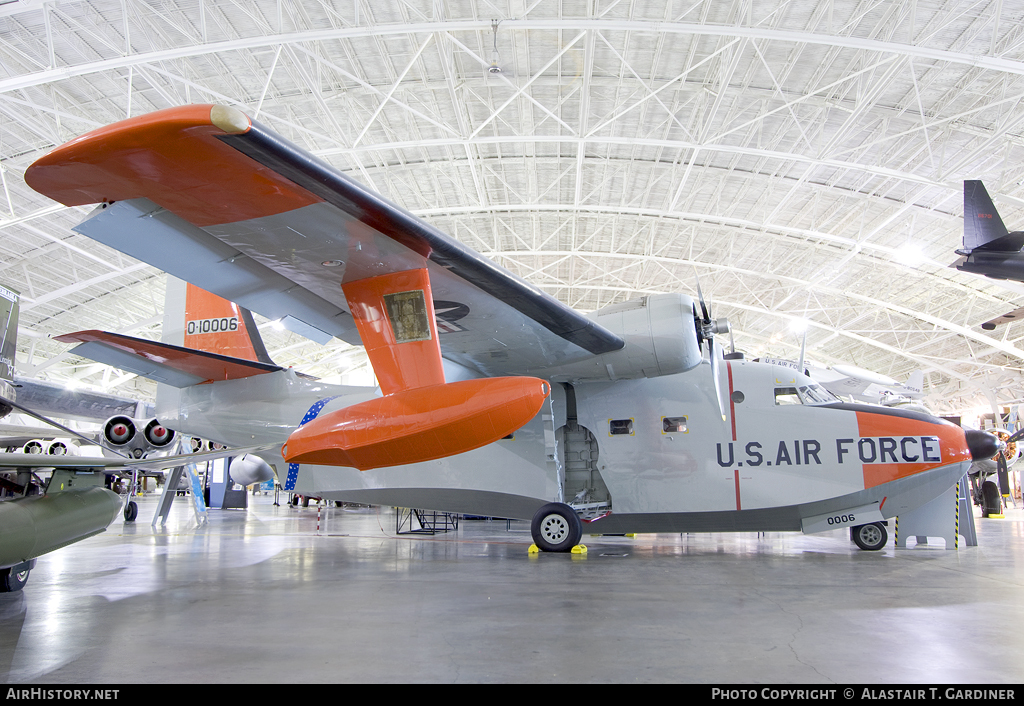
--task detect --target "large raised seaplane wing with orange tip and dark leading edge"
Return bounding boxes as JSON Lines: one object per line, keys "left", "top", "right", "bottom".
{"left": 26, "top": 106, "right": 624, "bottom": 376}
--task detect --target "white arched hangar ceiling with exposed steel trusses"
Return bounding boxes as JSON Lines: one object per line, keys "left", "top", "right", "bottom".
{"left": 0, "top": 0, "right": 1024, "bottom": 413}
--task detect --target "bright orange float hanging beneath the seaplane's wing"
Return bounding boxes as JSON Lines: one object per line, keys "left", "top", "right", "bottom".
{"left": 282, "top": 377, "right": 550, "bottom": 470}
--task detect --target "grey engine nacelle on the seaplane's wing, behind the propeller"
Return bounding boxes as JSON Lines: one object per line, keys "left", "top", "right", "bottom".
{"left": 548, "top": 294, "right": 703, "bottom": 381}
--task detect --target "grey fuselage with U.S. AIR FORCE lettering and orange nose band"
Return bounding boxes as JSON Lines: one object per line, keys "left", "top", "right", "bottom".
{"left": 158, "top": 361, "right": 970, "bottom": 532}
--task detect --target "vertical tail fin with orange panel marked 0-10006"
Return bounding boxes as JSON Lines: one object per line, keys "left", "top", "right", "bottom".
{"left": 163, "top": 277, "right": 273, "bottom": 365}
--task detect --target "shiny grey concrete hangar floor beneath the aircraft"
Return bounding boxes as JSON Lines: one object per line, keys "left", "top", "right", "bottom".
{"left": 0, "top": 489, "right": 1024, "bottom": 686}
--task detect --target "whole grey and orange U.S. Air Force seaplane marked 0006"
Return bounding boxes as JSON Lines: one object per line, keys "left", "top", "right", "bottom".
{"left": 26, "top": 106, "right": 994, "bottom": 551}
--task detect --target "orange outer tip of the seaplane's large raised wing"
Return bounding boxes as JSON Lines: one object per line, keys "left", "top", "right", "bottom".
{"left": 25, "top": 105, "right": 319, "bottom": 226}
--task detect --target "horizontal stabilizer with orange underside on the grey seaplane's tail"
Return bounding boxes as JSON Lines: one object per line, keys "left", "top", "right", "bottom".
{"left": 55, "top": 331, "right": 284, "bottom": 387}
